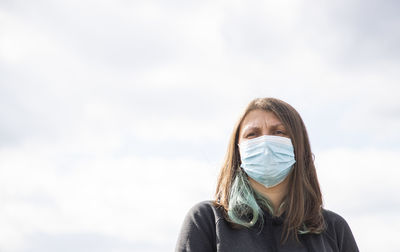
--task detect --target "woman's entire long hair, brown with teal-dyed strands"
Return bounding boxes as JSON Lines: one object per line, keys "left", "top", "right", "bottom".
{"left": 214, "top": 98, "right": 324, "bottom": 242}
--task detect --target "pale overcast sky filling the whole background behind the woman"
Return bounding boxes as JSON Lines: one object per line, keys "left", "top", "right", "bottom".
{"left": 0, "top": 0, "right": 400, "bottom": 252}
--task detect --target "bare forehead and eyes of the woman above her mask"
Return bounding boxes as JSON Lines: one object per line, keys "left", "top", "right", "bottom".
{"left": 239, "top": 109, "right": 289, "bottom": 144}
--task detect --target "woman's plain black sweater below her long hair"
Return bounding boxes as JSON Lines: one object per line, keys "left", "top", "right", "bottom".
{"left": 175, "top": 201, "right": 358, "bottom": 252}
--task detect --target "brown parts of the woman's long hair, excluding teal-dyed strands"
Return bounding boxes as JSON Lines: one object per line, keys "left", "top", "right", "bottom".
{"left": 215, "top": 98, "right": 324, "bottom": 241}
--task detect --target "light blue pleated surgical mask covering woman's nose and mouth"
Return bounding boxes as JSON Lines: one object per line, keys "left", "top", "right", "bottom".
{"left": 239, "top": 135, "right": 296, "bottom": 187}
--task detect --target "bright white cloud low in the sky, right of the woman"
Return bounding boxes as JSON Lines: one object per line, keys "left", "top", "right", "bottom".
{"left": 315, "top": 148, "right": 400, "bottom": 252}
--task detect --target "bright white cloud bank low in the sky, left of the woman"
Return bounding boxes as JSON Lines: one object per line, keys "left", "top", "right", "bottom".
{"left": 0, "top": 141, "right": 217, "bottom": 251}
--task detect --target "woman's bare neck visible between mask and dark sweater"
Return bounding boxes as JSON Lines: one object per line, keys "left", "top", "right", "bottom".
{"left": 249, "top": 177, "right": 288, "bottom": 216}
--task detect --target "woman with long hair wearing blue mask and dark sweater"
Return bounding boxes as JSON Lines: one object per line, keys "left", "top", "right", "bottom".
{"left": 176, "top": 98, "right": 358, "bottom": 252}
